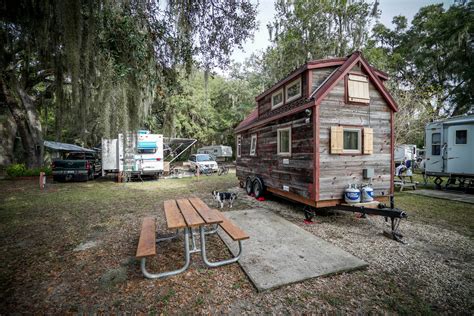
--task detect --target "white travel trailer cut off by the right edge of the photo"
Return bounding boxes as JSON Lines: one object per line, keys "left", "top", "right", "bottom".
{"left": 425, "top": 115, "right": 474, "bottom": 187}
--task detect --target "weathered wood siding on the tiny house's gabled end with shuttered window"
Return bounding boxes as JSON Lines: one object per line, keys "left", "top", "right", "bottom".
{"left": 319, "top": 67, "right": 391, "bottom": 200}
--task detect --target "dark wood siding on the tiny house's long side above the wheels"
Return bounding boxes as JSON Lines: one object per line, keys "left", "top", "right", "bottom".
{"left": 237, "top": 111, "right": 313, "bottom": 198}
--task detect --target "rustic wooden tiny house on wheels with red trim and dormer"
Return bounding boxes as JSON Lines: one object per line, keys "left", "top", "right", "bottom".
{"left": 235, "top": 52, "right": 397, "bottom": 210}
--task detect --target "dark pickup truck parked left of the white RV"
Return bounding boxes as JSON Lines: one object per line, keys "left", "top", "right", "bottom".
{"left": 51, "top": 152, "right": 102, "bottom": 181}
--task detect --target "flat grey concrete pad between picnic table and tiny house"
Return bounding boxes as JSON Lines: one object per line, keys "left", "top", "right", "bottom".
{"left": 219, "top": 209, "right": 367, "bottom": 291}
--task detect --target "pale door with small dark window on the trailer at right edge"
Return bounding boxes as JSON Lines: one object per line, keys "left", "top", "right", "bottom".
{"left": 446, "top": 125, "right": 474, "bottom": 174}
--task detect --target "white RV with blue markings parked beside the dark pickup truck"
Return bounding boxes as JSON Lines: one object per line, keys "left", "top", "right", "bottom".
{"left": 102, "top": 130, "right": 164, "bottom": 176}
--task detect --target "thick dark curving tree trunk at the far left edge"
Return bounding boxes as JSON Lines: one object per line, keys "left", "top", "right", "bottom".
{"left": 0, "top": 78, "right": 43, "bottom": 168}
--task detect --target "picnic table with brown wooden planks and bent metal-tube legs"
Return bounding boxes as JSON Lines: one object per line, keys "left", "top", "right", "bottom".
{"left": 136, "top": 197, "right": 249, "bottom": 279}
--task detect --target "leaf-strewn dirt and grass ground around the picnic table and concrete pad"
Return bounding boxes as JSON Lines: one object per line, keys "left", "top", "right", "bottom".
{"left": 0, "top": 174, "right": 474, "bottom": 314}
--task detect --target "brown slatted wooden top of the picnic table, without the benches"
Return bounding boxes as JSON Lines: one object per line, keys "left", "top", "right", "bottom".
{"left": 164, "top": 197, "right": 223, "bottom": 229}
